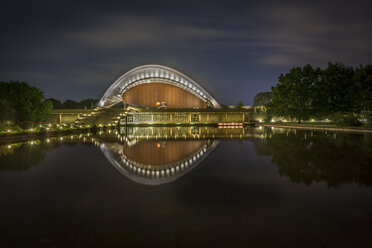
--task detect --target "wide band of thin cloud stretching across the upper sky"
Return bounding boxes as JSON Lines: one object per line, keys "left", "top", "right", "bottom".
{"left": 3, "top": 2, "right": 372, "bottom": 66}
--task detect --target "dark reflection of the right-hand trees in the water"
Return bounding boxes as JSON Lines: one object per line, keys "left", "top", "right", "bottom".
{"left": 255, "top": 130, "right": 372, "bottom": 187}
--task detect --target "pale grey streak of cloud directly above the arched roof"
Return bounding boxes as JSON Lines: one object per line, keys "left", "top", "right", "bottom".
{"left": 69, "top": 15, "right": 225, "bottom": 49}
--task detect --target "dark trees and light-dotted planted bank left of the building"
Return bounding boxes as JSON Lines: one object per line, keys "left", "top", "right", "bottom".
{"left": 0, "top": 81, "right": 109, "bottom": 134}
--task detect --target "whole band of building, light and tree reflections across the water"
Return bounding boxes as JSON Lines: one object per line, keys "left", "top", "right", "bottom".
{"left": 0, "top": 127, "right": 372, "bottom": 187}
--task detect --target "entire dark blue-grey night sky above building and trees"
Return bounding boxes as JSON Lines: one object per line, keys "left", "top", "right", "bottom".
{"left": 0, "top": 0, "right": 372, "bottom": 104}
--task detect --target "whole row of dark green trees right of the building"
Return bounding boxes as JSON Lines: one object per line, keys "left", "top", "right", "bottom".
{"left": 254, "top": 63, "right": 372, "bottom": 124}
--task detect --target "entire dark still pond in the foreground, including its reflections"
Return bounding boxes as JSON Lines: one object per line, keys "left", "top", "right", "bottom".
{"left": 0, "top": 128, "right": 372, "bottom": 247}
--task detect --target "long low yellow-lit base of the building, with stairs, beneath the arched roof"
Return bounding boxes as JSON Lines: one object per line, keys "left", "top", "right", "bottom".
{"left": 47, "top": 108, "right": 262, "bottom": 125}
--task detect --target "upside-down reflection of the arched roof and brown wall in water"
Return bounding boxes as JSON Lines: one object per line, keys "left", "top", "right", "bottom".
{"left": 101, "top": 139, "right": 219, "bottom": 185}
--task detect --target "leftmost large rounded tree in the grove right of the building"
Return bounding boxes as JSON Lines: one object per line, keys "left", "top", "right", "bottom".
{"left": 266, "top": 65, "right": 321, "bottom": 122}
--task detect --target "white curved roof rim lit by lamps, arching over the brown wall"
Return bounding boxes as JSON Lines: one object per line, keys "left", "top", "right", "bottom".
{"left": 98, "top": 65, "right": 221, "bottom": 108}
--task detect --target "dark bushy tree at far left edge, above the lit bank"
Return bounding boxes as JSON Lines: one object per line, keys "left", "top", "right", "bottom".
{"left": 0, "top": 81, "right": 52, "bottom": 122}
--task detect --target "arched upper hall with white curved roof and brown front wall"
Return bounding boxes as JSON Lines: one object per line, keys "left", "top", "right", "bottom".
{"left": 98, "top": 65, "right": 220, "bottom": 108}
